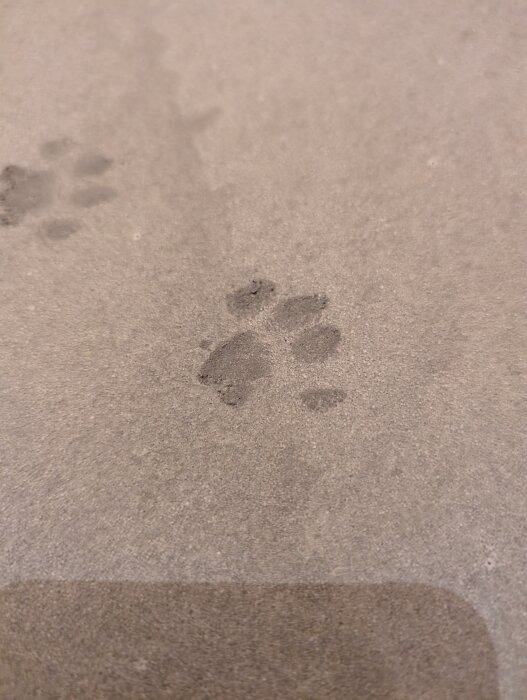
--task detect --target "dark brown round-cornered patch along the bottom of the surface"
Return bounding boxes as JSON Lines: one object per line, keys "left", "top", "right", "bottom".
{"left": 0, "top": 582, "right": 499, "bottom": 700}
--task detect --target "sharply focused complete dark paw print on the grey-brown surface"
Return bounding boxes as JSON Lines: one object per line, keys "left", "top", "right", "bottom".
{"left": 198, "top": 279, "right": 346, "bottom": 411}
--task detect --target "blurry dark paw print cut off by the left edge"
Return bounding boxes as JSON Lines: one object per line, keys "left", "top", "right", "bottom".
{"left": 0, "top": 138, "right": 117, "bottom": 240}
